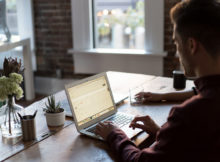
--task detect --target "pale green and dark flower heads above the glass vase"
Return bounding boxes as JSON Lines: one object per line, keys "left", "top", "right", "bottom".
{"left": 0, "top": 57, "right": 23, "bottom": 101}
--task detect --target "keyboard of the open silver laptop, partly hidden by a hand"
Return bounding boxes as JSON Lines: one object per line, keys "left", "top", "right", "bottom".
{"left": 87, "top": 114, "right": 133, "bottom": 133}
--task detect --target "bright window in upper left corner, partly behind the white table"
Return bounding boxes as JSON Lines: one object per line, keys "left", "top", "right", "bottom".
{"left": 0, "top": 0, "right": 36, "bottom": 70}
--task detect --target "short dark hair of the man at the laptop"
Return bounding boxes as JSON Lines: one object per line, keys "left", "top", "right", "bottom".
{"left": 170, "top": 0, "right": 220, "bottom": 56}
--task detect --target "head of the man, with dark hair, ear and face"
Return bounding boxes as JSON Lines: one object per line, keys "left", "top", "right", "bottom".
{"left": 170, "top": 0, "right": 220, "bottom": 76}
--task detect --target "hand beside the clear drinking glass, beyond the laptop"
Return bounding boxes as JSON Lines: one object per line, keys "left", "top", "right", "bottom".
{"left": 135, "top": 92, "right": 163, "bottom": 103}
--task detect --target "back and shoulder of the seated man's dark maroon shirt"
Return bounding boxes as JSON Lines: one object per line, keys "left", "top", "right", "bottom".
{"left": 154, "top": 76, "right": 220, "bottom": 161}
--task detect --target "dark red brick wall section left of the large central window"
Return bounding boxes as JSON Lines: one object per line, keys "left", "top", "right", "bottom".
{"left": 33, "top": 0, "right": 74, "bottom": 77}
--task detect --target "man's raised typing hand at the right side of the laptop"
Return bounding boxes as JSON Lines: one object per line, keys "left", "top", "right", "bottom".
{"left": 129, "top": 115, "right": 160, "bottom": 135}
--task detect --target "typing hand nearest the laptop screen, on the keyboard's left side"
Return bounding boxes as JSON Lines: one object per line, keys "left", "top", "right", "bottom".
{"left": 95, "top": 121, "right": 118, "bottom": 140}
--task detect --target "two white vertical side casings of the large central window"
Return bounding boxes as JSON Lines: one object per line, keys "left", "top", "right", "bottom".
{"left": 71, "top": 0, "right": 164, "bottom": 53}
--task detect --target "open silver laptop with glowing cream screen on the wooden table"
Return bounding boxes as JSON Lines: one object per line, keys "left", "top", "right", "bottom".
{"left": 65, "top": 73, "right": 142, "bottom": 140}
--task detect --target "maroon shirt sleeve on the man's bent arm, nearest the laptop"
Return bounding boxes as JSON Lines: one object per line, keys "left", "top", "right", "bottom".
{"left": 107, "top": 107, "right": 186, "bottom": 162}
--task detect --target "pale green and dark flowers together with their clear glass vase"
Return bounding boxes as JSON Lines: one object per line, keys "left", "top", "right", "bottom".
{"left": 0, "top": 57, "right": 23, "bottom": 138}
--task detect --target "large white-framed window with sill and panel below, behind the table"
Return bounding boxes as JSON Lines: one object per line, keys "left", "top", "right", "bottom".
{"left": 69, "top": 0, "right": 166, "bottom": 75}
